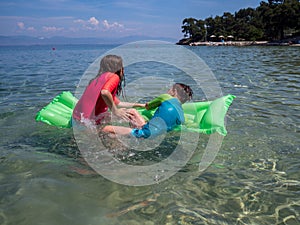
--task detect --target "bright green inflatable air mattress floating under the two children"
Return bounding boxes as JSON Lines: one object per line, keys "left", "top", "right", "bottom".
{"left": 36, "top": 91, "right": 235, "bottom": 136}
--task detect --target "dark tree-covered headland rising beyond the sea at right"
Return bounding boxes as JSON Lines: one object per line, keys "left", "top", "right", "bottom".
{"left": 178, "top": 0, "right": 300, "bottom": 44}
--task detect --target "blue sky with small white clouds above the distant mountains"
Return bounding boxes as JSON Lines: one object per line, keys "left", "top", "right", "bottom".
{"left": 0, "top": 0, "right": 261, "bottom": 39}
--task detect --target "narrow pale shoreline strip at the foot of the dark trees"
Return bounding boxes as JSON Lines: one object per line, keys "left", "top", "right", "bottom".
{"left": 177, "top": 41, "right": 300, "bottom": 46}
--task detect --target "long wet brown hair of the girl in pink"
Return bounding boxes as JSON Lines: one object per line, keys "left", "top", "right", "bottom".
{"left": 96, "top": 55, "right": 125, "bottom": 95}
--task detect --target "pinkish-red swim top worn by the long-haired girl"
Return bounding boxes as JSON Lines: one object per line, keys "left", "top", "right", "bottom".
{"left": 73, "top": 72, "right": 120, "bottom": 124}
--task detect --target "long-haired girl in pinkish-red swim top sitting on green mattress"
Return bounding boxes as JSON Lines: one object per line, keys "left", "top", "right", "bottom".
{"left": 73, "top": 55, "right": 145, "bottom": 125}
